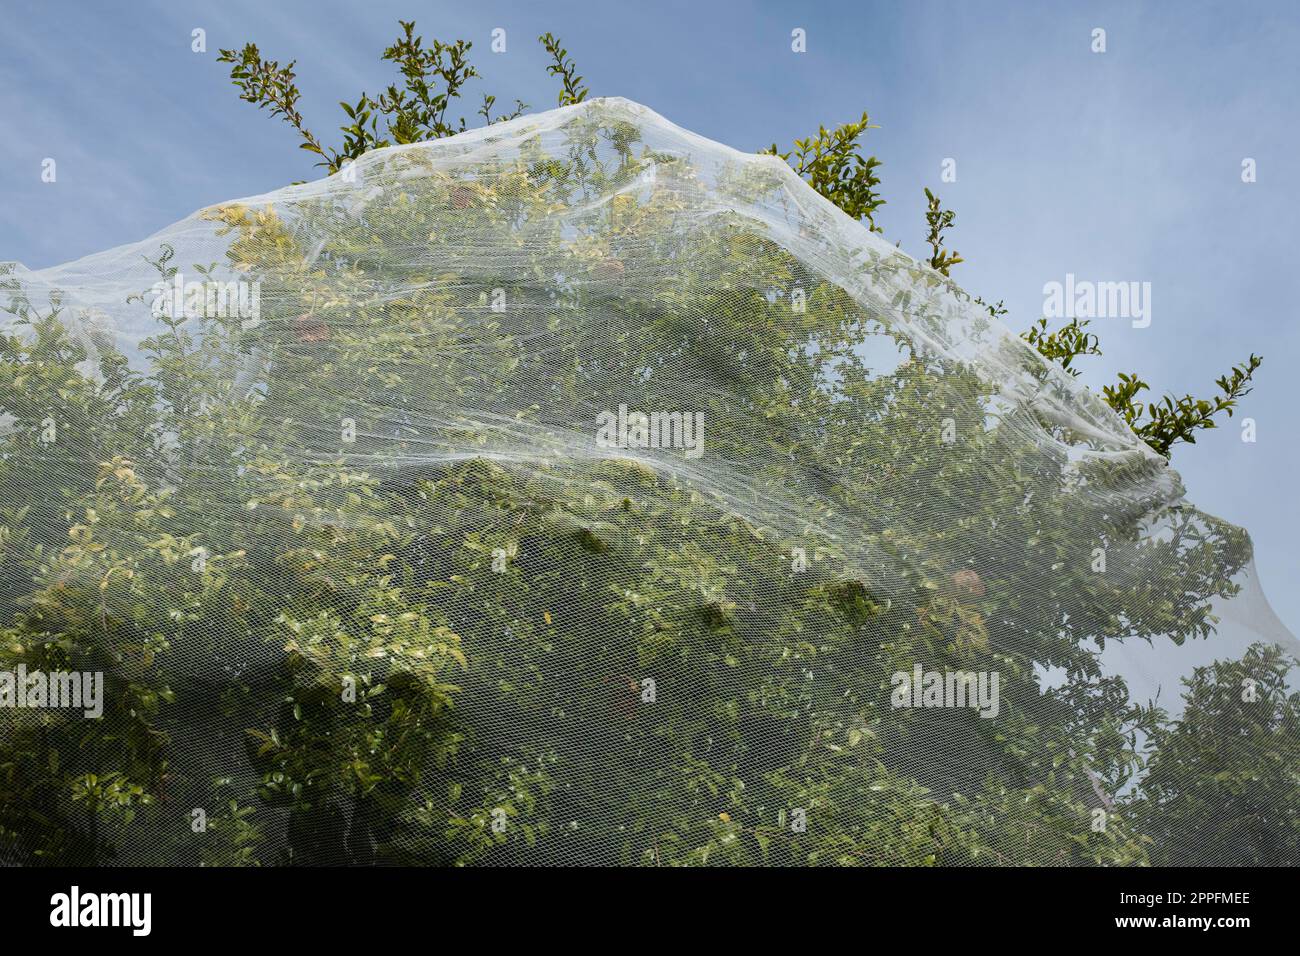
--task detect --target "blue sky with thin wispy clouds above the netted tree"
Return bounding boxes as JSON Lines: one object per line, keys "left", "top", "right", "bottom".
{"left": 0, "top": 0, "right": 1300, "bottom": 631}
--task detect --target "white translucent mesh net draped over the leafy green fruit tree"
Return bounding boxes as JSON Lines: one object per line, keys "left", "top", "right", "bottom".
{"left": 0, "top": 99, "right": 1300, "bottom": 865}
